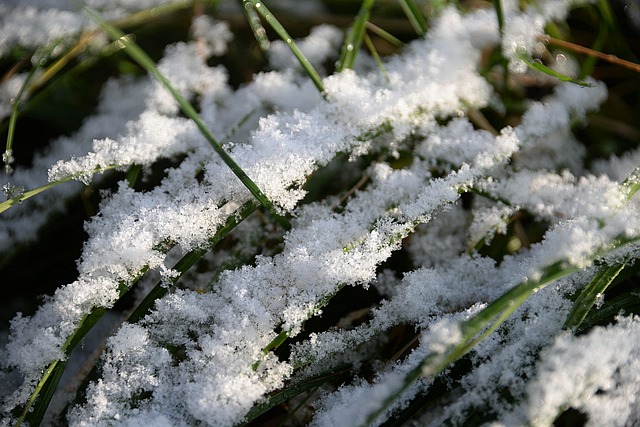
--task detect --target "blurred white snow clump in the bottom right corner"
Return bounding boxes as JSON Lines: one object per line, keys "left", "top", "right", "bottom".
{"left": 503, "top": 316, "right": 640, "bottom": 426}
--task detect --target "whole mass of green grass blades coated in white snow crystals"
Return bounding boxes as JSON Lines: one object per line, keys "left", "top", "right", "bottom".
{"left": 0, "top": 0, "right": 640, "bottom": 426}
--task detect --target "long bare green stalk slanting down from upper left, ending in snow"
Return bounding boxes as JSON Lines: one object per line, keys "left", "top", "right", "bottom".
{"left": 85, "top": 7, "right": 291, "bottom": 230}
